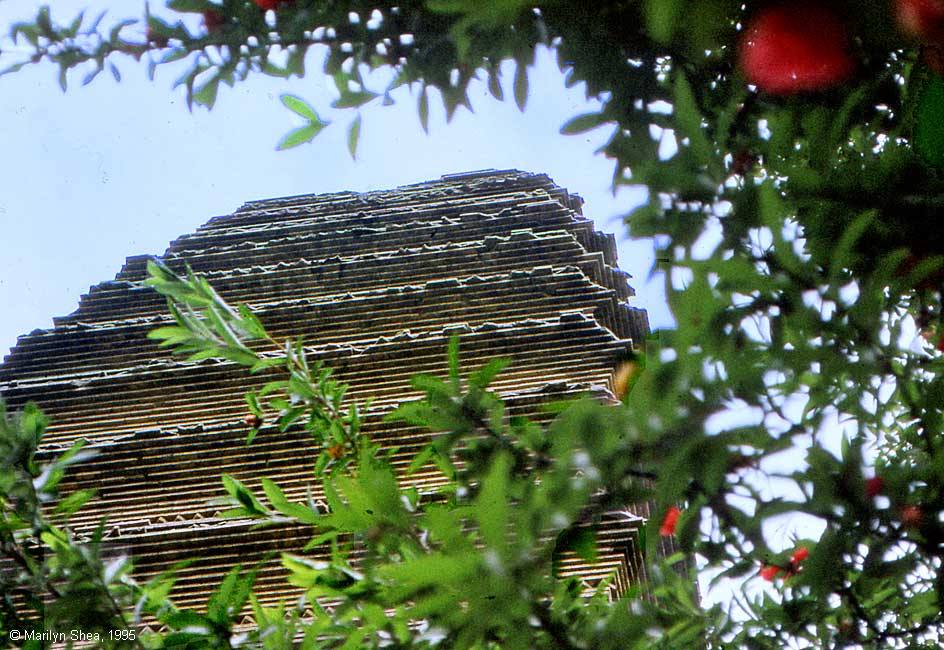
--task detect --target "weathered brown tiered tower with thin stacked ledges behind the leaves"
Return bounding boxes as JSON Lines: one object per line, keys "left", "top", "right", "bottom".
{"left": 0, "top": 171, "right": 648, "bottom": 620}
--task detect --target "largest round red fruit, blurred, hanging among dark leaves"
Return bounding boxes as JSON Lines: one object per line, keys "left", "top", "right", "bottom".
{"left": 739, "top": 2, "right": 855, "bottom": 95}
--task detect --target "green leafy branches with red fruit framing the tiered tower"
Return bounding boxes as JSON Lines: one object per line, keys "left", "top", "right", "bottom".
{"left": 0, "top": 0, "right": 944, "bottom": 648}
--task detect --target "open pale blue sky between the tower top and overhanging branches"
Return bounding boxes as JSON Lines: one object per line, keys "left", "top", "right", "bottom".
{"left": 0, "top": 0, "right": 671, "bottom": 356}
